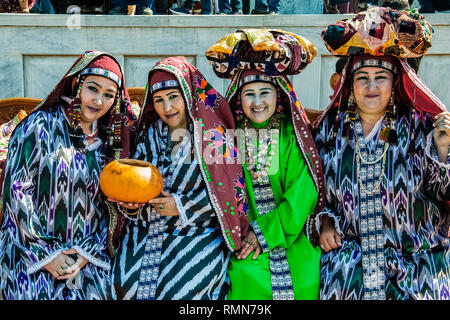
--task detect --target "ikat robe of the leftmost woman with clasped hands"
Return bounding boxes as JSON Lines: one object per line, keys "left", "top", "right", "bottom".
{"left": 0, "top": 107, "right": 110, "bottom": 300}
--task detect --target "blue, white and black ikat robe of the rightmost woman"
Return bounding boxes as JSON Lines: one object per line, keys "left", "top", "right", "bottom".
{"left": 316, "top": 111, "right": 450, "bottom": 300}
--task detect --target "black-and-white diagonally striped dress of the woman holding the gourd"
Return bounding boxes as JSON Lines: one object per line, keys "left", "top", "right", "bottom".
{"left": 111, "top": 120, "right": 230, "bottom": 300}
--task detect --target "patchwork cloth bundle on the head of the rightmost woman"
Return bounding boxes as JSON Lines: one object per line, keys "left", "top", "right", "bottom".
{"left": 322, "top": 7, "right": 433, "bottom": 58}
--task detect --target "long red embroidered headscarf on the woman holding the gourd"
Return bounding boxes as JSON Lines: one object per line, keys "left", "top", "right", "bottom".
{"left": 125, "top": 57, "right": 248, "bottom": 251}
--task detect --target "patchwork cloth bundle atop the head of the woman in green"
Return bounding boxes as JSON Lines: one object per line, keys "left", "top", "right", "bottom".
{"left": 206, "top": 29, "right": 317, "bottom": 79}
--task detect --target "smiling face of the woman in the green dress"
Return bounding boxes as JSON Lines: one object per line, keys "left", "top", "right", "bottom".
{"left": 241, "top": 82, "right": 277, "bottom": 123}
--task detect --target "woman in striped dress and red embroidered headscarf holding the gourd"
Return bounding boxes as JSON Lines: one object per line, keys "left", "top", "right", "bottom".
{"left": 110, "top": 57, "right": 248, "bottom": 300}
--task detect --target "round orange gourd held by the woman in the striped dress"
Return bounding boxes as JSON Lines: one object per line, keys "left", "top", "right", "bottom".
{"left": 100, "top": 159, "right": 163, "bottom": 203}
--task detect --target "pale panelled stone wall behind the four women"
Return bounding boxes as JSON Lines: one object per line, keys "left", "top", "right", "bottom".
{"left": 0, "top": 14, "right": 450, "bottom": 109}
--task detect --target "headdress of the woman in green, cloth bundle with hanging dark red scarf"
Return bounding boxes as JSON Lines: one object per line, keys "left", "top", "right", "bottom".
{"left": 206, "top": 29, "right": 325, "bottom": 213}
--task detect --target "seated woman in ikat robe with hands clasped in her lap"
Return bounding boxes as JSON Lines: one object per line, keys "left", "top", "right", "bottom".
{"left": 0, "top": 51, "right": 131, "bottom": 300}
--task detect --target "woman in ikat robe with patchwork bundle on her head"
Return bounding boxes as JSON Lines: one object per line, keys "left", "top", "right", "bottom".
{"left": 311, "top": 8, "right": 450, "bottom": 300}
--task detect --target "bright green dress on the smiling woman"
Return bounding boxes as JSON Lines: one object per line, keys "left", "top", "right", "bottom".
{"left": 228, "top": 116, "right": 320, "bottom": 300}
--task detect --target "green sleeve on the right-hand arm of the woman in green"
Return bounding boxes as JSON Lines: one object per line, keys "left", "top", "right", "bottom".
{"left": 253, "top": 119, "right": 317, "bottom": 249}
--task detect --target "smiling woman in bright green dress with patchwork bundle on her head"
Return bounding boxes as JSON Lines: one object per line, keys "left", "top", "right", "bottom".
{"left": 206, "top": 29, "right": 324, "bottom": 300}
